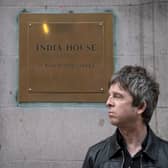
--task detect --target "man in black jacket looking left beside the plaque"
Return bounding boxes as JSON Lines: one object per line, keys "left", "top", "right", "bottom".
{"left": 83, "top": 66, "right": 168, "bottom": 168}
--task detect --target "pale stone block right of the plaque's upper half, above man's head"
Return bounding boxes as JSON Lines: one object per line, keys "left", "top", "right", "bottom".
{"left": 113, "top": 6, "right": 140, "bottom": 57}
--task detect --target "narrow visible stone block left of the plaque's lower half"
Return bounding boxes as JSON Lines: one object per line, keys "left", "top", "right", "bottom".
{"left": 0, "top": 56, "right": 19, "bottom": 107}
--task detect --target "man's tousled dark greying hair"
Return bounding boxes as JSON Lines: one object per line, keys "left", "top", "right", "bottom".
{"left": 109, "top": 65, "right": 159, "bottom": 123}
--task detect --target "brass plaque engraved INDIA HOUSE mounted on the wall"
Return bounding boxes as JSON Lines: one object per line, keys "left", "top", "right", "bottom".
{"left": 19, "top": 13, "right": 113, "bottom": 102}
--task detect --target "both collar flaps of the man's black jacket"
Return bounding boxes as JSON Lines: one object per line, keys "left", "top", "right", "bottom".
{"left": 109, "top": 126, "right": 159, "bottom": 161}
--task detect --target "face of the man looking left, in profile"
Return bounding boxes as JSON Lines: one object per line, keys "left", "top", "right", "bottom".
{"left": 106, "top": 83, "right": 139, "bottom": 127}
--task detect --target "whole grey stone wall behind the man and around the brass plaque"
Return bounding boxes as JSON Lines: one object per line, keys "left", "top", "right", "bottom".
{"left": 0, "top": 0, "right": 168, "bottom": 168}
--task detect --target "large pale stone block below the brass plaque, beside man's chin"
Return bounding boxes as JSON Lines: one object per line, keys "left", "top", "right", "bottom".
{"left": 0, "top": 107, "right": 114, "bottom": 162}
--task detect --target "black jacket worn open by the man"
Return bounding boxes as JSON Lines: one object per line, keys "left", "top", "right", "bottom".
{"left": 82, "top": 128, "right": 168, "bottom": 168}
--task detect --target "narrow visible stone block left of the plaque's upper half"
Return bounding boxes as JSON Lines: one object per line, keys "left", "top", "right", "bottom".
{"left": 0, "top": 7, "right": 21, "bottom": 56}
